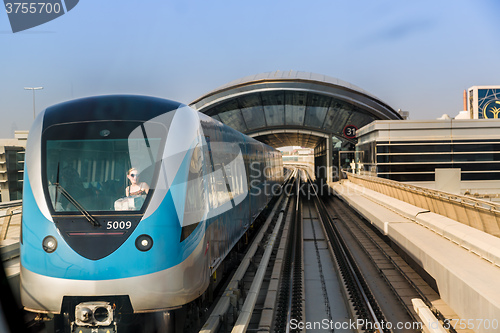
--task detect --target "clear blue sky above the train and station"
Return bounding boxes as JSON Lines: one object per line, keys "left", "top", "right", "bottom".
{"left": 0, "top": 0, "right": 500, "bottom": 138}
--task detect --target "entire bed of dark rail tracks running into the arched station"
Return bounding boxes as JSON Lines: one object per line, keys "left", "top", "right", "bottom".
{"left": 20, "top": 170, "right": 452, "bottom": 333}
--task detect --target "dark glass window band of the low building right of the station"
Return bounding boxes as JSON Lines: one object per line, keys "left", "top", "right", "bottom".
{"left": 356, "top": 140, "right": 500, "bottom": 181}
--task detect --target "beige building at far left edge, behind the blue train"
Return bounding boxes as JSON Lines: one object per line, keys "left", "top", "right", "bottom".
{"left": 0, "top": 131, "right": 28, "bottom": 202}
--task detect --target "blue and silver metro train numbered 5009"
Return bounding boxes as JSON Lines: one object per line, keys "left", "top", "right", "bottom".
{"left": 20, "top": 95, "right": 283, "bottom": 332}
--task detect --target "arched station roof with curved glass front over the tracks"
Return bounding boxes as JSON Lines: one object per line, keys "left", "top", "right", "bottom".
{"left": 191, "top": 71, "right": 402, "bottom": 180}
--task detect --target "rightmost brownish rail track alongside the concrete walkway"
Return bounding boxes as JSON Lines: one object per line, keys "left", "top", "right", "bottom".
{"left": 325, "top": 197, "right": 456, "bottom": 333}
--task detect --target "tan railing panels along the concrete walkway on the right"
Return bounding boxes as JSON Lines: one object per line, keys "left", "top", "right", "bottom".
{"left": 346, "top": 173, "right": 500, "bottom": 237}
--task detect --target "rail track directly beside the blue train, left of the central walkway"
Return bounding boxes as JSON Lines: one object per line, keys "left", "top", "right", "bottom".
{"left": 200, "top": 172, "right": 297, "bottom": 333}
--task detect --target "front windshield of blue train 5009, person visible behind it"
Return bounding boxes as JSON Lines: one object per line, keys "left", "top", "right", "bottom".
{"left": 42, "top": 121, "right": 167, "bottom": 214}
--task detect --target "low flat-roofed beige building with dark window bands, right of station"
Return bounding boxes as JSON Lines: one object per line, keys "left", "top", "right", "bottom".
{"left": 356, "top": 119, "right": 500, "bottom": 194}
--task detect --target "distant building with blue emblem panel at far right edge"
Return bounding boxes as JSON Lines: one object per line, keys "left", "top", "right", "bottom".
{"left": 467, "top": 86, "right": 500, "bottom": 119}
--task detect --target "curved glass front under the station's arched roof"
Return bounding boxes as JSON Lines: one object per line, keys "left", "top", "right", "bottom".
{"left": 203, "top": 90, "right": 377, "bottom": 148}
